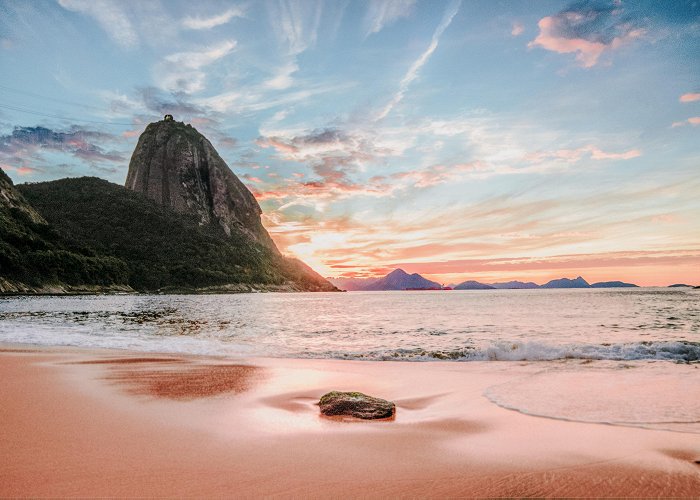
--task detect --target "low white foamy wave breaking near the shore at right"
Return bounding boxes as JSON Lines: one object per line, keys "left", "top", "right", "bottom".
{"left": 304, "top": 341, "right": 700, "bottom": 363}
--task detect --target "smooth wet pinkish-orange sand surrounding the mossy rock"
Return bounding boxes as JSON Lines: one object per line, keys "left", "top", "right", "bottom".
{"left": 0, "top": 345, "right": 700, "bottom": 497}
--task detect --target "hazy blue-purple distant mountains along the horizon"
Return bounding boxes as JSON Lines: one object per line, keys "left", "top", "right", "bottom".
{"left": 327, "top": 269, "right": 644, "bottom": 291}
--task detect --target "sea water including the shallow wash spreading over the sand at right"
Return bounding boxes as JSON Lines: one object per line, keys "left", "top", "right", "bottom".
{"left": 0, "top": 288, "right": 700, "bottom": 434}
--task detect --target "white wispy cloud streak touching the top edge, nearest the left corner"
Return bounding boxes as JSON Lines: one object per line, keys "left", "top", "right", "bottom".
{"left": 58, "top": 0, "right": 139, "bottom": 48}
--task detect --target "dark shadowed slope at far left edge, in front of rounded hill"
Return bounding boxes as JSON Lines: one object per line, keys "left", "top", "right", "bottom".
{"left": 0, "top": 169, "right": 130, "bottom": 293}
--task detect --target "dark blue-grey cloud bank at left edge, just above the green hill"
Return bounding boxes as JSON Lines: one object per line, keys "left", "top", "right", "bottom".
{"left": 0, "top": 127, "right": 126, "bottom": 164}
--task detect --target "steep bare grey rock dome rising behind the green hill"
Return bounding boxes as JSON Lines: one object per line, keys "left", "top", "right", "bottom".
{"left": 126, "top": 119, "right": 278, "bottom": 252}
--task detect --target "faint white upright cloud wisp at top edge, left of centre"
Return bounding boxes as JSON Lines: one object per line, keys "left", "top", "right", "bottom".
{"left": 267, "top": 0, "right": 323, "bottom": 55}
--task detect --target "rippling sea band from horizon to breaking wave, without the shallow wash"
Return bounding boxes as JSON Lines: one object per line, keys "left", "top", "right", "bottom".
{"left": 0, "top": 288, "right": 700, "bottom": 362}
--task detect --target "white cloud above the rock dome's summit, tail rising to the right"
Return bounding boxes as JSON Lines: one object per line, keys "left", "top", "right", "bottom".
{"left": 155, "top": 40, "right": 236, "bottom": 94}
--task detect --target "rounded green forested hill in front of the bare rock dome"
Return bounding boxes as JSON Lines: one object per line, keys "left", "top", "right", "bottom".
{"left": 18, "top": 177, "right": 335, "bottom": 291}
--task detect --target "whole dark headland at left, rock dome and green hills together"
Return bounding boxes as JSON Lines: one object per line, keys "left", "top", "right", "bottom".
{"left": 0, "top": 117, "right": 337, "bottom": 294}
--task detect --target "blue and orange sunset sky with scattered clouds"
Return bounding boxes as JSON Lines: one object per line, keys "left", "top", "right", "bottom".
{"left": 0, "top": 0, "right": 700, "bottom": 285}
